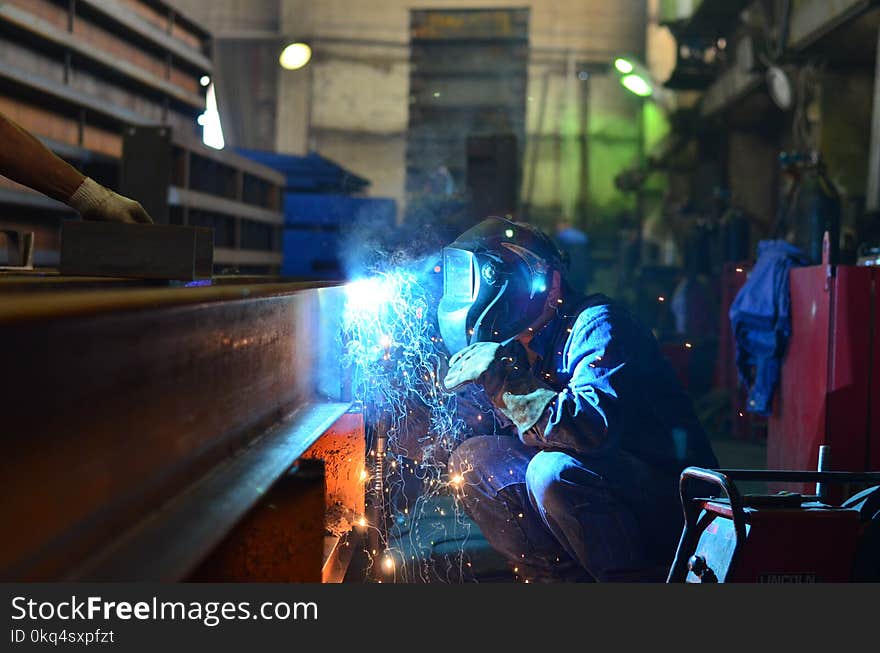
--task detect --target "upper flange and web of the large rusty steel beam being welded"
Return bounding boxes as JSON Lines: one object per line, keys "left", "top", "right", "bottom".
{"left": 0, "top": 284, "right": 347, "bottom": 580}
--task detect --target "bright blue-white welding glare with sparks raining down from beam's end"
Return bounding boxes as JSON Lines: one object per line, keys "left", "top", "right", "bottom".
{"left": 341, "top": 262, "right": 480, "bottom": 581}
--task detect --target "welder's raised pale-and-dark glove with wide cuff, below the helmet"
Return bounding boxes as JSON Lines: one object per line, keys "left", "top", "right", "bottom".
{"left": 443, "top": 340, "right": 556, "bottom": 433}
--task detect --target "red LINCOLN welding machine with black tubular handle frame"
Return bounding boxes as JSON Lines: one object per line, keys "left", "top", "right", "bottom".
{"left": 667, "top": 467, "right": 880, "bottom": 583}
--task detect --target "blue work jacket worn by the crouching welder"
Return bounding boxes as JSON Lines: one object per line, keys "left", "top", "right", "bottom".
{"left": 464, "top": 295, "right": 718, "bottom": 473}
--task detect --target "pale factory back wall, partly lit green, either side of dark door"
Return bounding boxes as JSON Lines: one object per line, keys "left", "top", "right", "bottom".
{"left": 176, "top": 0, "right": 646, "bottom": 226}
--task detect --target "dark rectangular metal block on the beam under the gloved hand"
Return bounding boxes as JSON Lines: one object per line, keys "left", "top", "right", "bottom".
{"left": 60, "top": 220, "right": 214, "bottom": 281}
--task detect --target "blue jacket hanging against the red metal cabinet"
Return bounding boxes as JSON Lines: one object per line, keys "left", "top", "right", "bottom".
{"left": 728, "top": 240, "right": 808, "bottom": 415}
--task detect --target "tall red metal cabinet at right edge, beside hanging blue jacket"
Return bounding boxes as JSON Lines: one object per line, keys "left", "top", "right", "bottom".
{"left": 767, "top": 265, "right": 880, "bottom": 492}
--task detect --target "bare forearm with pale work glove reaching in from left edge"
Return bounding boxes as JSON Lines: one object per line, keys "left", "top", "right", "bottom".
{"left": 0, "top": 113, "right": 152, "bottom": 223}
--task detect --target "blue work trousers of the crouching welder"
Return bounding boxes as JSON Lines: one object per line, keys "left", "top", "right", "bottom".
{"left": 449, "top": 436, "right": 683, "bottom": 582}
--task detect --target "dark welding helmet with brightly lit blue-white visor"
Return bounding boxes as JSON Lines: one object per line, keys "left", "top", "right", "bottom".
{"left": 437, "top": 217, "right": 563, "bottom": 354}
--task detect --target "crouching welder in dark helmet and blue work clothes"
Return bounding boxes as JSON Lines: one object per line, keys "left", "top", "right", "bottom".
{"left": 438, "top": 217, "right": 717, "bottom": 582}
